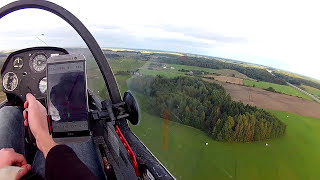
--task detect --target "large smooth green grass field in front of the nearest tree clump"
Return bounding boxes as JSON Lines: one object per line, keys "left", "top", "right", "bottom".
{"left": 131, "top": 94, "right": 320, "bottom": 180}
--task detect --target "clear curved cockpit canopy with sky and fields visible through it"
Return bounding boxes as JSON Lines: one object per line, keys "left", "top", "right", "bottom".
{"left": 0, "top": 1, "right": 320, "bottom": 180}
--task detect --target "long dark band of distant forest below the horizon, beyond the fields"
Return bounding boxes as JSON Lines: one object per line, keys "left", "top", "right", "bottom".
{"left": 154, "top": 55, "right": 286, "bottom": 85}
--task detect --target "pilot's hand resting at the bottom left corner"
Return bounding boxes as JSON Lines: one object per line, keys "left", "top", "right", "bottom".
{"left": 0, "top": 148, "right": 31, "bottom": 179}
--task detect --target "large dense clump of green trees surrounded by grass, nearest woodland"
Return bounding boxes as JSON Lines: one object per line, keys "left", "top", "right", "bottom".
{"left": 129, "top": 76, "right": 286, "bottom": 142}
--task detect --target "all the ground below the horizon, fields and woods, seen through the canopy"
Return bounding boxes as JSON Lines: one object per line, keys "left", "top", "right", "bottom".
{"left": 0, "top": 49, "right": 320, "bottom": 180}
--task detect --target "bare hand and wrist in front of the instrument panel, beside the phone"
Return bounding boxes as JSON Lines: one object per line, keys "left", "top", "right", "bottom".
{"left": 23, "top": 93, "right": 56, "bottom": 157}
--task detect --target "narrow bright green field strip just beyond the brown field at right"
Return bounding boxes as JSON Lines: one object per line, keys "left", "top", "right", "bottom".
{"left": 243, "top": 79, "right": 312, "bottom": 101}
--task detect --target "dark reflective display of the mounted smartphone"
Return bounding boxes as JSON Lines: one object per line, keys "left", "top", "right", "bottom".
{"left": 47, "top": 61, "right": 88, "bottom": 124}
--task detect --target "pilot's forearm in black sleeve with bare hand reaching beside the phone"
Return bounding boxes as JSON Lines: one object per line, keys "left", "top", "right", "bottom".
{"left": 23, "top": 94, "right": 98, "bottom": 180}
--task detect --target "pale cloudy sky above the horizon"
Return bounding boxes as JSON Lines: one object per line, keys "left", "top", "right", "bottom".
{"left": 0, "top": 0, "right": 320, "bottom": 79}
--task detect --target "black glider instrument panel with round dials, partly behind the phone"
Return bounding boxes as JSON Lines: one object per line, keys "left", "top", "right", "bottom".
{"left": 1, "top": 47, "right": 69, "bottom": 102}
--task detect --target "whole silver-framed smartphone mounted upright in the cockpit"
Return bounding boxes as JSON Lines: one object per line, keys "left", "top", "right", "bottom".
{"left": 47, "top": 54, "right": 90, "bottom": 140}
